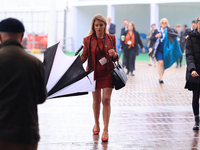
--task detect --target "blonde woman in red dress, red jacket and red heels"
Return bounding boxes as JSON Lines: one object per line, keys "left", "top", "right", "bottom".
{"left": 81, "top": 14, "right": 119, "bottom": 142}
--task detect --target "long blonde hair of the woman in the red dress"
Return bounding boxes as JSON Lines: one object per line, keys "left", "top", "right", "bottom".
{"left": 88, "top": 14, "right": 109, "bottom": 36}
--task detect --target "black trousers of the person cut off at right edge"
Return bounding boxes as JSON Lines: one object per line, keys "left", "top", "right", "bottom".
{"left": 192, "top": 91, "right": 200, "bottom": 116}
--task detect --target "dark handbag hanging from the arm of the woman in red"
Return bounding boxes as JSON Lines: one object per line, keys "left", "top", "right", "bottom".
{"left": 112, "top": 61, "right": 127, "bottom": 90}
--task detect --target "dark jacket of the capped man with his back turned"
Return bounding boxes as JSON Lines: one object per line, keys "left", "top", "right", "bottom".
{"left": 0, "top": 40, "right": 46, "bottom": 144}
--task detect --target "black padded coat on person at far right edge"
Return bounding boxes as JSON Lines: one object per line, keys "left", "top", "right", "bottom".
{"left": 186, "top": 30, "right": 200, "bottom": 90}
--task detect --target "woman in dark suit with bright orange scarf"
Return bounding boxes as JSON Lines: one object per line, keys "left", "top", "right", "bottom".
{"left": 122, "top": 22, "right": 145, "bottom": 76}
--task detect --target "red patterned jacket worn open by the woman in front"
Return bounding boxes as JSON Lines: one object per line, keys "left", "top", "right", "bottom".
{"left": 81, "top": 34, "right": 119, "bottom": 81}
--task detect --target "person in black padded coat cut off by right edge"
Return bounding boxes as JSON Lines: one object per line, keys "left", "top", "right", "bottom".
{"left": 185, "top": 17, "right": 200, "bottom": 130}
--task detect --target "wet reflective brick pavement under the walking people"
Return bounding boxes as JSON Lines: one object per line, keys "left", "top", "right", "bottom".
{"left": 32, "top": 54, "right": 200, "bottom": 150}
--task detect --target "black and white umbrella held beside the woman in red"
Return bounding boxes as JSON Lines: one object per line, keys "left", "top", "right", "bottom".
{"left": 43, "top": 43, "right": 95, "bottom": 98}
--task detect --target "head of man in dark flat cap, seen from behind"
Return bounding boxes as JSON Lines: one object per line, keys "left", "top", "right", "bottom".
{"left": 0, "top": 18, "right": 25, "bottom": 43}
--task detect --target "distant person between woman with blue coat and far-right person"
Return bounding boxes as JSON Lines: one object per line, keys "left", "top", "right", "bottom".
{"left": 176, "top": 24, "right": 185, "bottom": 68}
